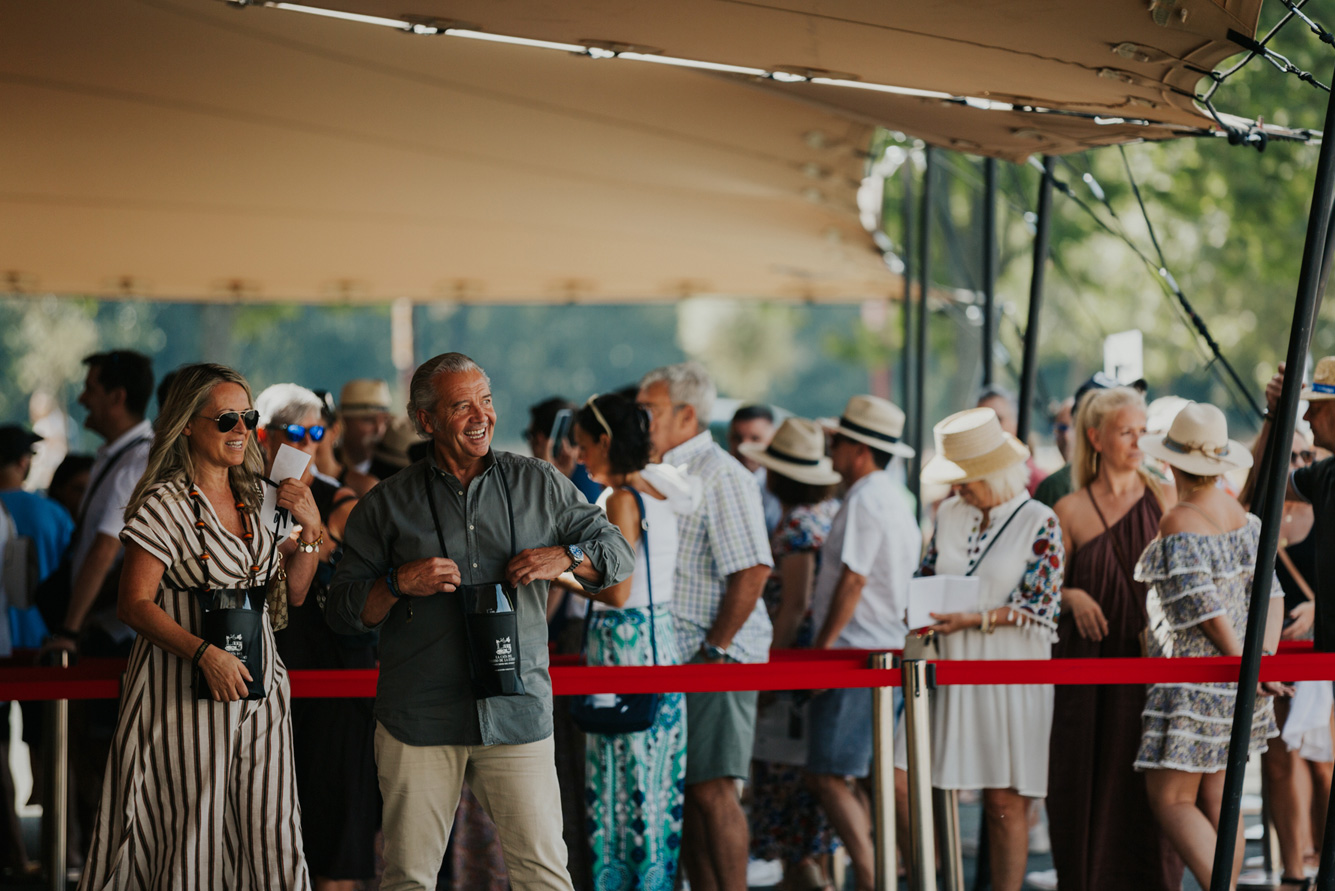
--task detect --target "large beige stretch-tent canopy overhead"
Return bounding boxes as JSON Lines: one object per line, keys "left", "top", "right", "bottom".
{"left": 0, "top": 0, "right": 1292, "bottom": 302}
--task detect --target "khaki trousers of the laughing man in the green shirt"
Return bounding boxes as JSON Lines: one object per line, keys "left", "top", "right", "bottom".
{"left": 375, "top": 723, "right": 573, "bottom": 891}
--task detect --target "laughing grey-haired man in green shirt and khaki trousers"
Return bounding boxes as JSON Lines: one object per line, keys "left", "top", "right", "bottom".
{"left": 326, "top": 353, "right": 634, "bottom": 891}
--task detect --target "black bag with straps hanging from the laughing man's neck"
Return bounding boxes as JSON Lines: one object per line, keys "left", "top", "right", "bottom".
{"left": 426, "top": 465, "right": 523, "bottom": 699}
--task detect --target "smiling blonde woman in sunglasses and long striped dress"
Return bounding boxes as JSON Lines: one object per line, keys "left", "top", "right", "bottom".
{"left": 79, "top": 365, "right": 323, "bottom": 891}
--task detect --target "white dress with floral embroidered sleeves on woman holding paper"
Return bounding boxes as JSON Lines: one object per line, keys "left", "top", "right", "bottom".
{"left": 896, "top": 493, "right": 1065, "bottom": 797}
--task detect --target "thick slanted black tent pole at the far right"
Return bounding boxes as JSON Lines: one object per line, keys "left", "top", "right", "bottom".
{"left": 1210, "top": 62, "right": 1335, "bottom": 891}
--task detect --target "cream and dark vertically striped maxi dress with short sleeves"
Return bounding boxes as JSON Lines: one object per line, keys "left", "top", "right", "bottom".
{"left": 79, "top": 481, "right": 311, "bottom": 891}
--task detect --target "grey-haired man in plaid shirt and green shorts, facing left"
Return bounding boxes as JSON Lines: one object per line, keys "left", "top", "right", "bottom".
{"left": 639, "top": 362, "right": 773, "bottom": 891}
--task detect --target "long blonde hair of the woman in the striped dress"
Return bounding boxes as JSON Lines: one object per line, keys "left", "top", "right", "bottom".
{"left": 125, "top": 363, "right": 264, "bottom": 516}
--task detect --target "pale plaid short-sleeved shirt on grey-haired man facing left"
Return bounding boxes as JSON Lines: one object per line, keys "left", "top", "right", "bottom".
{"left": 663, "top": 431, "right": 774, "bottom": 663}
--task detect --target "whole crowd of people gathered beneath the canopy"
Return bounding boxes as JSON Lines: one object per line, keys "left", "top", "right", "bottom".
{"left": 0, "top": 350, "right": 1335, "bottom": 891}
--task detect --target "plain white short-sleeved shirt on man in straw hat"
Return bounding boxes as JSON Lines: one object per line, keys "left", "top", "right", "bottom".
{"left": 812, "top": 470, "right": 922, "bottom": 649}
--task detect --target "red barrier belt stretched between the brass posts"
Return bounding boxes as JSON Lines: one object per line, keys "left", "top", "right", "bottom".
{"left": 0, "top": 641, "right": 1335, "bottom": 700}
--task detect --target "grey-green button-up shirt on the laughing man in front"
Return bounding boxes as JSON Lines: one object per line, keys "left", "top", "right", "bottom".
{"left": 326, "top": 452, "right": 635, "bottom": 745}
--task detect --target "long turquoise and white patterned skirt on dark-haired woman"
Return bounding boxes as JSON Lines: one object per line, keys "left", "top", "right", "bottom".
{"left": 585, "top": 606, "right": 686, "bottom": 891}
